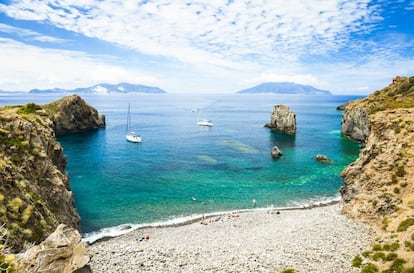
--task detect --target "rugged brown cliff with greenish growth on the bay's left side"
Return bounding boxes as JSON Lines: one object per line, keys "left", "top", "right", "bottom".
{"left": 0, "top": 95, "right": 105, "bottom": 251}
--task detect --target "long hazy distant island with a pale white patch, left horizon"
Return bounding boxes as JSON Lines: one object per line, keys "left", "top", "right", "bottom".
{"left": 29, "top": 82, "right": 167, "bottom": 94}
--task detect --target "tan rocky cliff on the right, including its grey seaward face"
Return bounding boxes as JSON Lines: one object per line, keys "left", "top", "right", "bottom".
{"left": 341, "top": 77, "right": 414, "bottom": 272}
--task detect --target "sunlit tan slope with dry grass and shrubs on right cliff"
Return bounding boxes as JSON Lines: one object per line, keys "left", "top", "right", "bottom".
{"left": 347, "top": 77, "right": 414, "bottom": 273}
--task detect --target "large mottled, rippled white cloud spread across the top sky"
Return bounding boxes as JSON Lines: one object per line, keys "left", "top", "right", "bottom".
{"left": 0, "top": 0, "right": 378, "bottom": 67}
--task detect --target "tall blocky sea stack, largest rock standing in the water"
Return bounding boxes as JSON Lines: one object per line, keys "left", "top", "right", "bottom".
{"left": 265, "top": 104, "right": 296, "bottom": 135}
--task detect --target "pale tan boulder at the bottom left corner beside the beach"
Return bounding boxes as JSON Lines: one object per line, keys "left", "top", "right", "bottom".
{"left": 17, "top": 224, "right": 92, "bottom": 273}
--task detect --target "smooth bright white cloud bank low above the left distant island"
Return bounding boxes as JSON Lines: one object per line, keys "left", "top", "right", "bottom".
{"left": 0, "top": 38, "right": 157, "bottom": 91}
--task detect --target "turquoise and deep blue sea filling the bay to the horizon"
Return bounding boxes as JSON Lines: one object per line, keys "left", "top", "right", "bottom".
{"left": 0, "top": 93, "right": 359, "bottom": 242}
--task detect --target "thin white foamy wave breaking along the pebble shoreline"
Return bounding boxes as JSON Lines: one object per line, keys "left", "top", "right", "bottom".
{"left": 82, "top": 195, "right": 341, "bottom": 244}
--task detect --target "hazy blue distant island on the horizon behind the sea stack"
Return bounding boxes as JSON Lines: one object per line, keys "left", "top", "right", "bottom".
{"left": 237, "top": 82, "right": 332, "bottom": 95}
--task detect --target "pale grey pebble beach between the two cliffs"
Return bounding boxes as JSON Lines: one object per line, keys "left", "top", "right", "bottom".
{"left": 90, "top": 204, "right": 375, "bottom": 273}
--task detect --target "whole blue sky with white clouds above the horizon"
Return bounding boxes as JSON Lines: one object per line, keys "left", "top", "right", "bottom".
{"left": 0, "top": 0, "right": 414, "bottom": 94}
